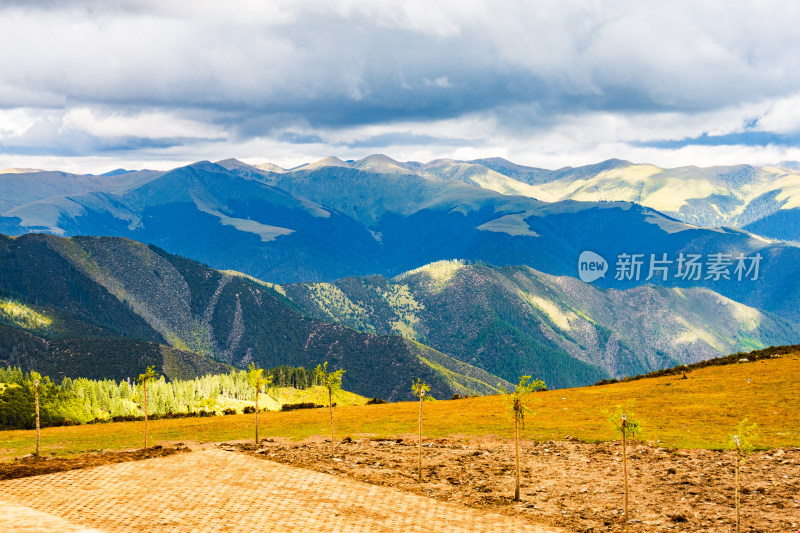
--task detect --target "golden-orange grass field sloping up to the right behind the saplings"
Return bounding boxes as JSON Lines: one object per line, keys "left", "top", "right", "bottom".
{"left": 0, "top": 354, "right": 800, "bottom": 461}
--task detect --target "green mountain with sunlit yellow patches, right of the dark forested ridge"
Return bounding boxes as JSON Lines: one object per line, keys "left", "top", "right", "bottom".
{"left": 284, "top": 261, "right": 800, "bottom": 387}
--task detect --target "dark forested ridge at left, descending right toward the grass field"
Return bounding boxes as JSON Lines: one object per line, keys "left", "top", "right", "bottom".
{"left": 0, "top": 234, "right": 508, "bottom": 400}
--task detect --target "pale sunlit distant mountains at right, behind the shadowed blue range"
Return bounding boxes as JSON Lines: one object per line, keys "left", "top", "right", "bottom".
{"left": 412, "top": 159, "right": 800, "bottom": 240}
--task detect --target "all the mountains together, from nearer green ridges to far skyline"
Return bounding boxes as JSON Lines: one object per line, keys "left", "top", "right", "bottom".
{"left": 0, "top": 155, "right": 800, "bottom": 399}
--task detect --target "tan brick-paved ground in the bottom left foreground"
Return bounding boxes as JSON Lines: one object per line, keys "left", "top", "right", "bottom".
{"left": 0, "top": 449, "right": 561, "bottom": 533}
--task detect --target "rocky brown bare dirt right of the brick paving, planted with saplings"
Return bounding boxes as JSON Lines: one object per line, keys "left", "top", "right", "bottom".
{"left": 220, "top": 438, "right": 800, "bottom": 533}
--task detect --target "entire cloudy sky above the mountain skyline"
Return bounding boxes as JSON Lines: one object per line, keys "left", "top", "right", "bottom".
{"left": 0, "top": 0, "right": 800, "bottom": 173}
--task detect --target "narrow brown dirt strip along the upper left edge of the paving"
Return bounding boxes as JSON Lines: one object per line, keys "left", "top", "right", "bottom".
{"left": 0, "top": 444, "right": 190, "bottom": 480}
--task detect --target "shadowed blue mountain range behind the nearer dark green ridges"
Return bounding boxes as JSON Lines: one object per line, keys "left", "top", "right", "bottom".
{"left": 6, "top": 156, "right": 800, "bottom": 321}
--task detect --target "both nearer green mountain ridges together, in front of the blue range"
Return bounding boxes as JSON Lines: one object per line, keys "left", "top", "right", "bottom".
{"left": 0, "top": 234, "right": 800, "bottom": 390}
